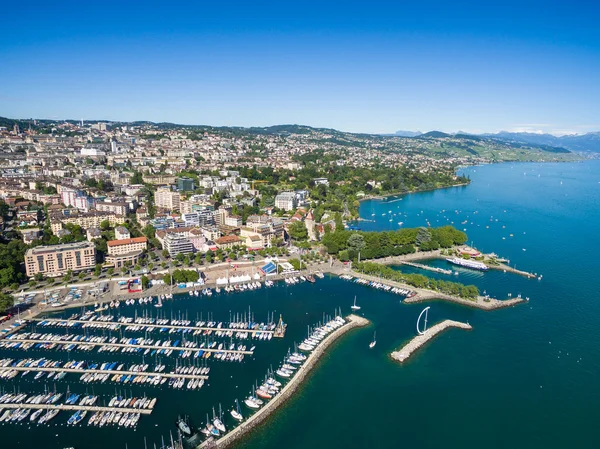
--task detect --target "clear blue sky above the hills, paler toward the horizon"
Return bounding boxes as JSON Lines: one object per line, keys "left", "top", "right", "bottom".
{"left": 0, "top": 0, "right": 600, "bottom": 133}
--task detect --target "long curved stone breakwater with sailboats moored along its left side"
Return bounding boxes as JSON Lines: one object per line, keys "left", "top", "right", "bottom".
{"left": 198, "top": 315, "right": 369, "bottom": 449}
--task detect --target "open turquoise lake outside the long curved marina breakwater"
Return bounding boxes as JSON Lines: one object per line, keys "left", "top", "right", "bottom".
{"left": 234, "top": 161, "right": 600, "bottom": 449}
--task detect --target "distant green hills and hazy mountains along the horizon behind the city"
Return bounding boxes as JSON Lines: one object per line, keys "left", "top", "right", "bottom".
{"left": 0, "top": 117, "right": 580, "bottom": 163}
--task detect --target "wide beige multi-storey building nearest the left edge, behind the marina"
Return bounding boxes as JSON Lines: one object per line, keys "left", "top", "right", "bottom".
{"left": 25, "top": 242, "right": 96, "bottom": 277}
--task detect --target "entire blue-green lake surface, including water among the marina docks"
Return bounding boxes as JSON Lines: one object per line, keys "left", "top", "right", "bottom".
{"left": 0, "top": 161, "right": 600, "bottom": 449}
